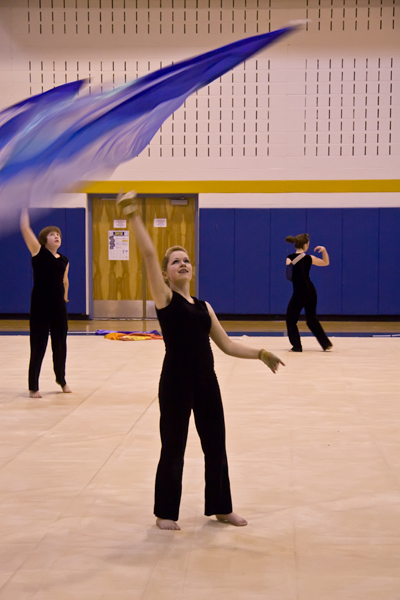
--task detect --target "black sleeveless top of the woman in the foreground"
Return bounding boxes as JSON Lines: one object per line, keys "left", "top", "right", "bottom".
{"left": 156, "top": 292, "right": 214, "bottom": 378}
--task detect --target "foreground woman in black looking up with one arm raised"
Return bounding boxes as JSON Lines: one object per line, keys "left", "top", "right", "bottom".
{"left": 119, "top": 192, "right": 283, "bottom": 530}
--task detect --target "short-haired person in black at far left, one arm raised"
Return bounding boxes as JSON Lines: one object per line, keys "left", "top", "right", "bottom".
{"left": 20, "top": 210, "right": 71, "bottom": 398}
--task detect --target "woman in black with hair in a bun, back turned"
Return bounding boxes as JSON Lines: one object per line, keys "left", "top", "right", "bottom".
{"left": 285, "top": 233, "right": 332, "bottom": 352}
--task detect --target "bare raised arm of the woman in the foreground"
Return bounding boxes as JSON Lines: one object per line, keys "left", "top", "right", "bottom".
{"left": 131, "top": 210, "right": 172, "bottom": 308}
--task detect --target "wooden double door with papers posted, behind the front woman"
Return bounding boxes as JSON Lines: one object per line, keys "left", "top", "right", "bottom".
{"left": 92, "top": 196, "right": 196, "bottom": 319}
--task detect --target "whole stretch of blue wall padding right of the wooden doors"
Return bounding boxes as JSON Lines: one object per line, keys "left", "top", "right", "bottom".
{"left": 198, "top": 208, "right": 400, "bottom": 316}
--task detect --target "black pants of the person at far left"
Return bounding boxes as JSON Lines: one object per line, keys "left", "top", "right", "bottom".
{"left": 28, "top": 307, "right": 68, "bottom": 392}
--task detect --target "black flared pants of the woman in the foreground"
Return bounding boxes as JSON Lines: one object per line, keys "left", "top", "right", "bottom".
{"left": 154, "top": 369, "right": 232, "bottom": 521}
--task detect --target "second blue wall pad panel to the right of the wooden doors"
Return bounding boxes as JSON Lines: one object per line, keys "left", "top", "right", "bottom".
{"left": 234, "top": 209, "right": 271, "bottom": 315}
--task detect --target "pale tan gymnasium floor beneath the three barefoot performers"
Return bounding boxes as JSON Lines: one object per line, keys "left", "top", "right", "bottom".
{"left": 0, "top": 321, "right": 400, "bottom": 600}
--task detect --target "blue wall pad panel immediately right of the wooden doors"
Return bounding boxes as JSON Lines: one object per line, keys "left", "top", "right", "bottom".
{"left": 199, "top": 208, "right": 235, "bottom": 313}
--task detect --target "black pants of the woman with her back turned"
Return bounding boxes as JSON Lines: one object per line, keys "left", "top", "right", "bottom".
{"left": 286, "top": 290, "right": 332, "bottom": 351}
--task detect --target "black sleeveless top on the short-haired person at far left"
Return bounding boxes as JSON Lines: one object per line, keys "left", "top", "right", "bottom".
{"left": 31, "top": 246, "right": 68, "bottom": 312}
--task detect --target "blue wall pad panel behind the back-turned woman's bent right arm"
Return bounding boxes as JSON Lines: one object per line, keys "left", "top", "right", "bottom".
{"left": 307, "top": 208, "right": 343, "bottom": 315}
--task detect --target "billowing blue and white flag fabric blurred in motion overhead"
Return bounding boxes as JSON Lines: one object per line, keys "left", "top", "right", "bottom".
{"left": 0, "top": 25, "right": 297, "bottom": 232}
